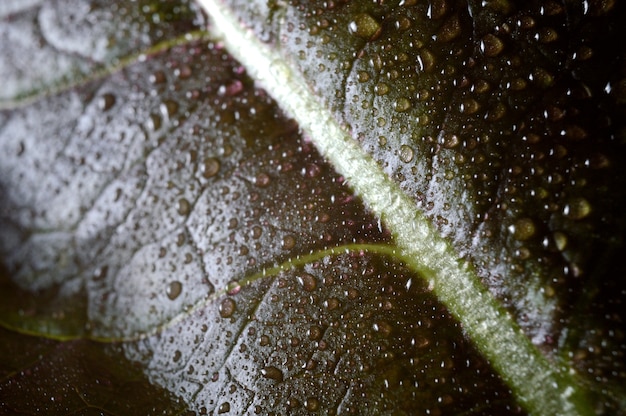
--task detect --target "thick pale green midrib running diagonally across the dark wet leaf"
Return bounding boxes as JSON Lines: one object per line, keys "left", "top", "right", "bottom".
{"left": 199, "top": 0, "right": 593, "bottom": 415}
